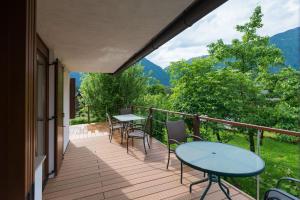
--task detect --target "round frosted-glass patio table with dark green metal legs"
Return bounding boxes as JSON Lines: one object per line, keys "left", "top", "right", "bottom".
{"left": 175, "top": 141, "right": 265, "bottom": 200}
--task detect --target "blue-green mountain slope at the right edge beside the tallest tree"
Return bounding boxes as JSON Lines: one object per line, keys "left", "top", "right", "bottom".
{"left": 270, "top": 27, "right": 300, "bottom": 70}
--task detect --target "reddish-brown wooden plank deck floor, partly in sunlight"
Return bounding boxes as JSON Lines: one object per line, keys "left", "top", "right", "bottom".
{"left": 43, "top": 124, "right": 251, "bottom": 200}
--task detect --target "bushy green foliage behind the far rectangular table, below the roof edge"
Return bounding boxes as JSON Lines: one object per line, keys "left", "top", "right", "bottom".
{"left": 80, "top": 65, "right": 148, "bottom": 118}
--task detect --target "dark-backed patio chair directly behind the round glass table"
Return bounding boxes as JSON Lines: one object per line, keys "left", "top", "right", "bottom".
{"left": 166, "top": 120, "right": 202, "bottom": 184}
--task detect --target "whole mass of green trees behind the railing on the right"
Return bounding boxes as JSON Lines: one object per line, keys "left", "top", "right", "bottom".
{"left": 169, "top": 6, "right": 300, "bottom": 151}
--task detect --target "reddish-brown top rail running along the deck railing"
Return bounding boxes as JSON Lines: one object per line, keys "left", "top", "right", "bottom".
{"left": 134, "top": 106, "right": 300, "bottom": 137}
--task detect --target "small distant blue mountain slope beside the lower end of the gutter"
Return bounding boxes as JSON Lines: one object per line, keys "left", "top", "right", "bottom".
{"left": 139, "top": 58, "right": 170, "bottom": 86}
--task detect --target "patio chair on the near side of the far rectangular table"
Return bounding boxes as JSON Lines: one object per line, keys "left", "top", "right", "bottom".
{"left": 127, "top": 115, "right": 152, "bottom": 154}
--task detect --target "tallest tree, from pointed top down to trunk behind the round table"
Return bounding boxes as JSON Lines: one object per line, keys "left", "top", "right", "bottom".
{"left": 209, "top": 6, "right": 284, "bottom": 151}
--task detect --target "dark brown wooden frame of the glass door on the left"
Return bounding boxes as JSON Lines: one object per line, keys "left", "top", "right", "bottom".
{"left": 35, "top": 34, "right": 49, "bottom": 188}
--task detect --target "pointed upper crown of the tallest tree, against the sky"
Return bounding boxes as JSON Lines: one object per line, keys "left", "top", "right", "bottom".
{"left": 208, "top": 6, "right": 284, "bottom": 77}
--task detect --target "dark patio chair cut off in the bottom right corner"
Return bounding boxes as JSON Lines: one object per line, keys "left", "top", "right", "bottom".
{"left": 264, "top": 177, "right": 300, "bottom": 200}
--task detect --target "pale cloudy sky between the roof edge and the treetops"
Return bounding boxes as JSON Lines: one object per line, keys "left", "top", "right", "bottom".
{"left": 147, "top": 0, "right": 300, "bottom": 68}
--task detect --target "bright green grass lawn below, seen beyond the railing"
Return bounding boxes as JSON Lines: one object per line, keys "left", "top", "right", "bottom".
{"left": 228, "top": 134, "right": 300, "bottom": 199}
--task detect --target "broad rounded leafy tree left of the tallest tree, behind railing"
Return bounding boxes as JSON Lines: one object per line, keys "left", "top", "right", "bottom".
{"left": 170, "top": 57, "right": 260, "bottom": 145}
